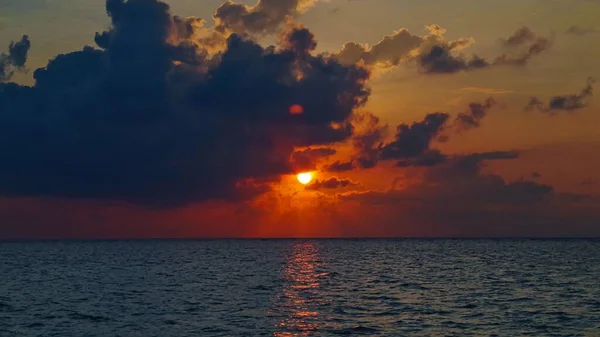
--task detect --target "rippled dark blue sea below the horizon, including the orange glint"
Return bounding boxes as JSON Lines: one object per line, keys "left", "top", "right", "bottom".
{"left": 0, "top": 240, "right": 600, "bottom": 337}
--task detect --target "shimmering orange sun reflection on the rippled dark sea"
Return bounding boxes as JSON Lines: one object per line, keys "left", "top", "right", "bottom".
{"left": 273, "top": 242, "right": 329, "bottom": 337}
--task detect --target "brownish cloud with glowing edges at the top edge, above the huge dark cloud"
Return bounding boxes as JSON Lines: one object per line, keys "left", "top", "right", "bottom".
{"left": 214, "top": 0, "right": 314, "bottom": 34}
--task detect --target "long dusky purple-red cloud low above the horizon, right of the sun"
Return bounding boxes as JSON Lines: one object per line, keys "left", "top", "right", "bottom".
{"left": 341, "top": 152, "right": 553, "bottom": 212}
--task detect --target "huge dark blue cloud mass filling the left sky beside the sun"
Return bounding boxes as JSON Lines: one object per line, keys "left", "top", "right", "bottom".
{"left": 0, "top": 0, "right": 369, "bottom": 205}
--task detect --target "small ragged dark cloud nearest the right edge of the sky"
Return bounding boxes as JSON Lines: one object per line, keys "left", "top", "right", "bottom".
{"left": 525, "top": 77, "right": 596, "bottom": 115}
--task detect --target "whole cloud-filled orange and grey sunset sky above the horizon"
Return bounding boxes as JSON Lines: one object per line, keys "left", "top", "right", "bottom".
{"left": 0, "top": 0, "right": 600, "bottom": 239}
